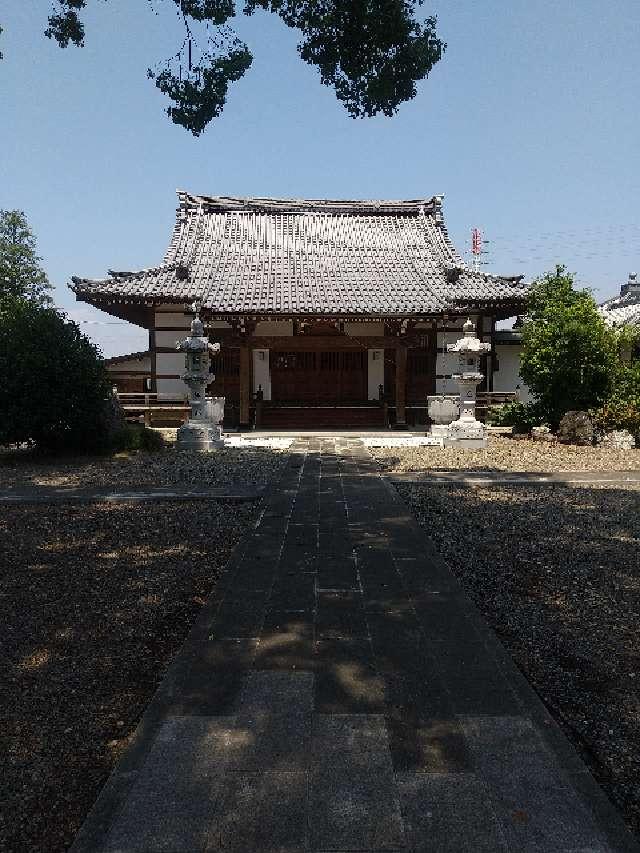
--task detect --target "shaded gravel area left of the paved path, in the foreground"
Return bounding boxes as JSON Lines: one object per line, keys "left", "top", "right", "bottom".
{"left": 0, "top": 500, "right": 265, "bottom": 853}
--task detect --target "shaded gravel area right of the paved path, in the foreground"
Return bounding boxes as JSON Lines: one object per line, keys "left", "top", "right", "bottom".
{"left": 398, "top": 484, "right": 640, "bottom": 836}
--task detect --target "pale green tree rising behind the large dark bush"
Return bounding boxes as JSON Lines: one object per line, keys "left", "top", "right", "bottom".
{"left": 0, "top": 210, "right": 51, "bottom": 305}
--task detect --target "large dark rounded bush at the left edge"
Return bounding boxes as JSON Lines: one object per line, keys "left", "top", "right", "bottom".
{"left": 0, "top": 296, "right": 110, "bottom": 452}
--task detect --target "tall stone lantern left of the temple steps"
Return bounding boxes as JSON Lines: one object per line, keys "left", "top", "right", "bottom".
{"left": 176, "top": 303, "right": 224, "bottom": 450}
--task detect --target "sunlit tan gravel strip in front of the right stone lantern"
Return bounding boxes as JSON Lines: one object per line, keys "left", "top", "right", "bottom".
{"left": 371, "top": 436, "right": 640, "bottom": 474}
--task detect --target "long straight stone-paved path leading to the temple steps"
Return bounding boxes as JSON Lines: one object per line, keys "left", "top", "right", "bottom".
{"left": 73, "top": 438, "right": 640, "bottom": 853}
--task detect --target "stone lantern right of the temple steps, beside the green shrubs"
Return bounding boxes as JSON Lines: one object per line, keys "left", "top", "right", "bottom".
{"left": 444, "top": 320, "right": 491, "bottom": 449}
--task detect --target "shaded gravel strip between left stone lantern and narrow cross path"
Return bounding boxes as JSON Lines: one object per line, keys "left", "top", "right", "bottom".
{"left": 0, "top": 447, "right": 284, "bottom": 489}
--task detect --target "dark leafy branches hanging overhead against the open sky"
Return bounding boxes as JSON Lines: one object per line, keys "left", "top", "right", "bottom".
{"left": 0, "top": 0, "right": 446, "bottom": 136}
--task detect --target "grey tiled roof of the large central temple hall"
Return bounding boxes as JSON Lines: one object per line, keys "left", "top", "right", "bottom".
{"left": 71, "top": 192, "right": 527, "bottom": 316}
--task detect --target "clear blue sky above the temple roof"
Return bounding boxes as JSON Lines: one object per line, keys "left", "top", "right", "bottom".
{"left": 0, "top": 0, "right": 640, "bottom": 355}
